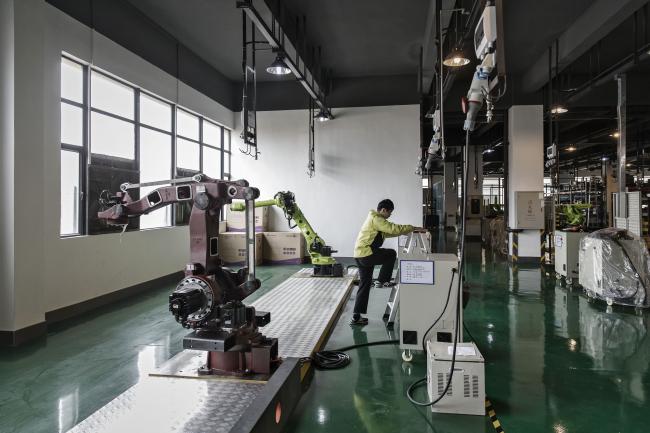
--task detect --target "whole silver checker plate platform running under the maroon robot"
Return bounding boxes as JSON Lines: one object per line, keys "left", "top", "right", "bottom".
{"left": 70, "top": 268, "right": 353, "bottom": 433}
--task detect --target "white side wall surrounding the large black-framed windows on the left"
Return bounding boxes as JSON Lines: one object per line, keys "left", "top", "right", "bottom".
{"left": 0, "top": 0, "right": 234, "bottom": 330}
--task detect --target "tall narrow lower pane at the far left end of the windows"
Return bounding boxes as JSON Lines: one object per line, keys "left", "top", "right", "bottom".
{"left": 61, "top": 150, "right": 80, "bottom": 235}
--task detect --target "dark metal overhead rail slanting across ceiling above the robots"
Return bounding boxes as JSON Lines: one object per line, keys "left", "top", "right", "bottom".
{"left": 237, "top": 0, "right": 328, "bottom": 112}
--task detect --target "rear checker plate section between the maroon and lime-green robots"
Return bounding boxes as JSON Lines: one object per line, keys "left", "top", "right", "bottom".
{"left": 252, "top": 268, "right": 352, "bottom": 358}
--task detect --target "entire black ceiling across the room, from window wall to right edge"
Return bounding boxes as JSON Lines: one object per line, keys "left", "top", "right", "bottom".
{"left": 47, "top": 0, "right": 650, "bottom": 174}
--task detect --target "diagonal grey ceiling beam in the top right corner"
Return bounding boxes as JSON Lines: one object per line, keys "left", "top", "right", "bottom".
{"left": 523, "top": 0, "right": 648, "bottom": 93}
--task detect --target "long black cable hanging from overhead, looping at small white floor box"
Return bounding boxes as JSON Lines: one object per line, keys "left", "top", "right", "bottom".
{"left": 406, "top": 130, "right": 469, "bottom": 406}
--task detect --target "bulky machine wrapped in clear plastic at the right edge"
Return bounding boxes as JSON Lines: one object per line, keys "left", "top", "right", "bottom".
{"left": 579, "top": 228, "right": 650, "bottom": 308}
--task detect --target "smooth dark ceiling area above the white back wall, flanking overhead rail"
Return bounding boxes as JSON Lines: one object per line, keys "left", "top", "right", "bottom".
{"left": 127, "top": 0, "right": 429, "bottom": 81}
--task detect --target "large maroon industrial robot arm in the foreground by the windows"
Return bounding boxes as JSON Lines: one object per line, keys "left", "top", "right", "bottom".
{"left": 97, "top": 175, "right": 277, "bottom": 374}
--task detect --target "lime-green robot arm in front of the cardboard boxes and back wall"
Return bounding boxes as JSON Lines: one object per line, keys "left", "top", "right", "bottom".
{"left": 230, "top": 191, "right": 343, "bottom": 277}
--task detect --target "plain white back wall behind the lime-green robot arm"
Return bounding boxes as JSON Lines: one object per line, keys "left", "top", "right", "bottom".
{"left": 232, "top": 105, "right": 422, "bottom": 257}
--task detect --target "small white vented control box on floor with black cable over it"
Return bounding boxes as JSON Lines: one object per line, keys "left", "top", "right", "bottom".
{"left": 427, "top": 341, "right": 485, "bottom": 416}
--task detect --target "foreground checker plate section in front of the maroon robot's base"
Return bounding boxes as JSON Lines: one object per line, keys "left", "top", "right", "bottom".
{"left": 69, "top": 377, "right": 264, "bottom": 433}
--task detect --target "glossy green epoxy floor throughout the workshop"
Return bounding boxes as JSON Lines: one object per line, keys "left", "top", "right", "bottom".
{"left": 0, "top": 238, "right": 650, "bottom": 433}
